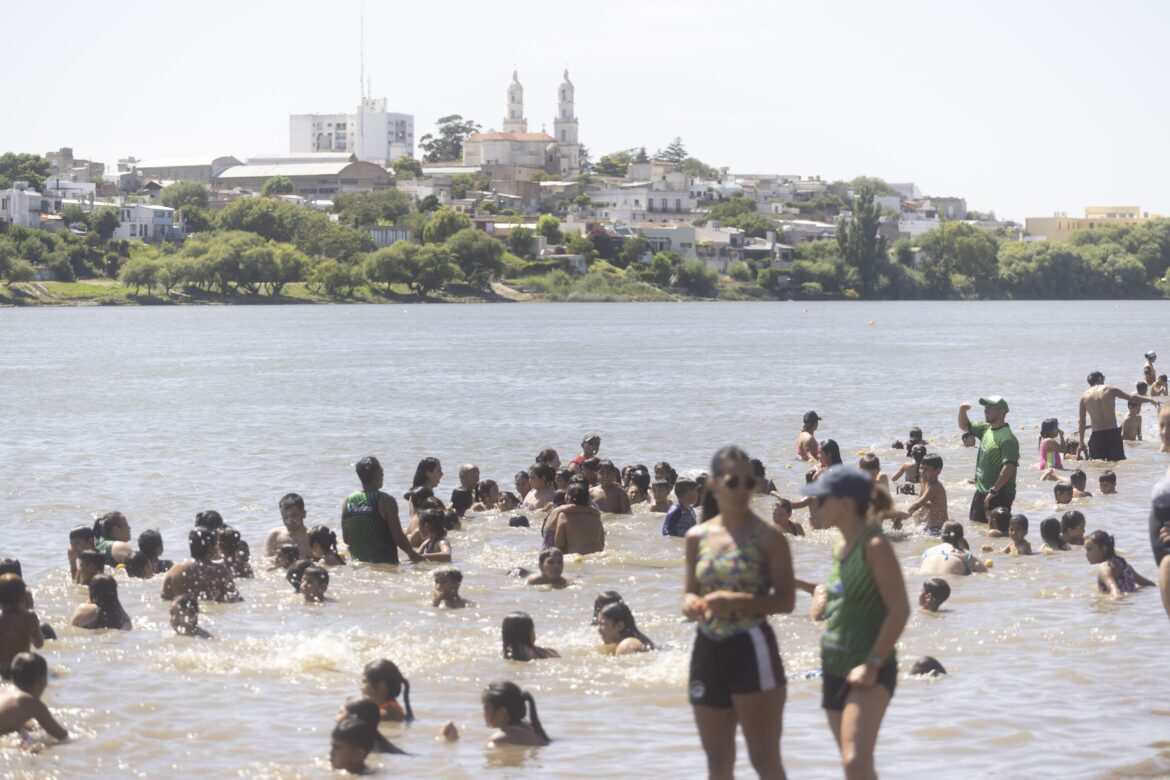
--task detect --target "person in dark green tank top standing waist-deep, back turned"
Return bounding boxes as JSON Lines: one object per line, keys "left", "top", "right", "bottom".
{"left": 342, "top": 455, "right": 422, "bottom": 564}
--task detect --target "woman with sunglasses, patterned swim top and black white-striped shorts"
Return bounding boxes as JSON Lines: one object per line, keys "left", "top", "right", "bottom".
{"left": 682, "top": 447, "right": 796, "bottom": 778}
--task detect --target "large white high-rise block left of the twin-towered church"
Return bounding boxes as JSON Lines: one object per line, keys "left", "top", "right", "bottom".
{"left": 289, "top": 98, "right": 414, "bottom": 166}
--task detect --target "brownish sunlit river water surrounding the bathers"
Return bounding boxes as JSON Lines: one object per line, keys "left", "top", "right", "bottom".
{"left": 0, "top": 302, "right": 1170, "bottom": 778}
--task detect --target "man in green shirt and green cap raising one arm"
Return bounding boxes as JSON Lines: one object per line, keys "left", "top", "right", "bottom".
{"left": 958, "top": 395, "right": 1020, "bottom": 523}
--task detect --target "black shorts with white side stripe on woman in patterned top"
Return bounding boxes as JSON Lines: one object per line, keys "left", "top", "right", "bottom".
{"left": 689, "top": 623, "right": 787, "bottom": 710}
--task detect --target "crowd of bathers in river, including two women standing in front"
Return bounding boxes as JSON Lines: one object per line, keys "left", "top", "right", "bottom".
{"left": 0, "top": 352, "right": 1170, "bottom": 778}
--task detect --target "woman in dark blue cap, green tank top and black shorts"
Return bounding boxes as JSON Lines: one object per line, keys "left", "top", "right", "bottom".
{"left": 801, "top": 465, "right": 910, "bottom": 779}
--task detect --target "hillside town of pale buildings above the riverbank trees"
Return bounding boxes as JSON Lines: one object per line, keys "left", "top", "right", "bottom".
{"left": 0, "top": 70, "right": 1164, "bottom": 297}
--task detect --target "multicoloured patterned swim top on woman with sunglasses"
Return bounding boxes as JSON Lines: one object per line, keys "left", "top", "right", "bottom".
{"left": 695, "top": 524, "right": 772, "bottom": 640}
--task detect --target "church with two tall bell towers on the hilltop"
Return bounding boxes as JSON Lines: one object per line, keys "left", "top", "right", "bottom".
{"left": 463, "top": 70, "right": 581, "bottom": 179}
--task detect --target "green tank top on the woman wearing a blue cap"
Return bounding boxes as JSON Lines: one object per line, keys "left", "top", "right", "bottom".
{"left": 820, "top": 526, "right": 897, "bottom": 677}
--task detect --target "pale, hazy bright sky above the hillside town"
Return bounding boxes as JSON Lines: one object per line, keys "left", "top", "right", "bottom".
{"left": 0, "top": 0, "right": 1170, "bottom": 220}
